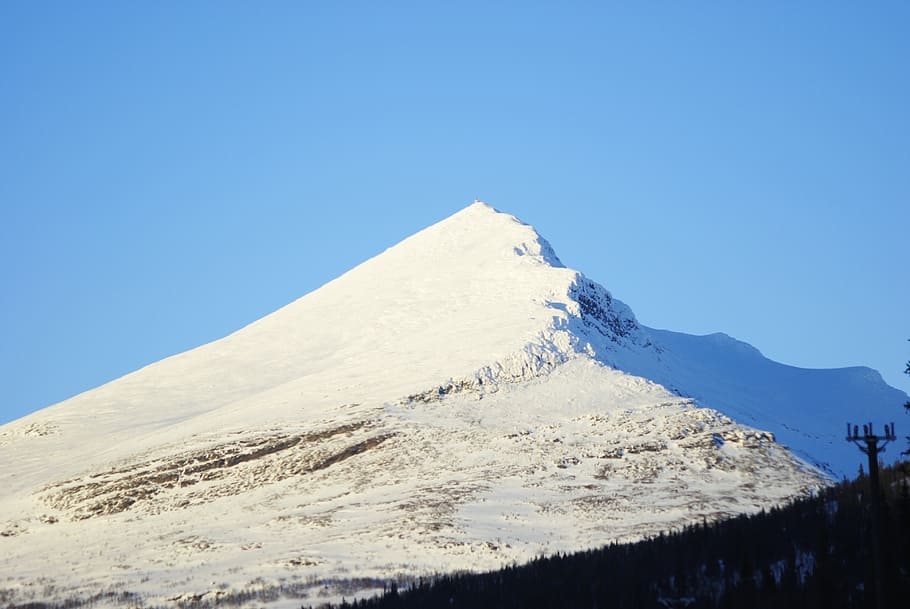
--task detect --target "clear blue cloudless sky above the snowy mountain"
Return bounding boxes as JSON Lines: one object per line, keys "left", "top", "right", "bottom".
{"left": 0, "top": 0, "right": 910, "bottom": 422}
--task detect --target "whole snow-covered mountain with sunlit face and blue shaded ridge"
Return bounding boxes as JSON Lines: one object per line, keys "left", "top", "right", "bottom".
{"left": 0, "top": 203, "right": 907, "bottom": 606}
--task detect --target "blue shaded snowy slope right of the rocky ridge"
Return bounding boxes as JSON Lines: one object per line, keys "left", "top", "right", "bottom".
{"left": 620, "top": 328, "right": 907, "bottom": 478}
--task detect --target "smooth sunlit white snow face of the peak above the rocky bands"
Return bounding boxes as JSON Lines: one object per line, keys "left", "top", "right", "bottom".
{"left": 5, "top": 202, "right": 596, "bottom": 443}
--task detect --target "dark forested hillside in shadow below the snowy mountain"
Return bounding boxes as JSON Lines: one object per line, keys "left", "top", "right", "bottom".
{"left": 343, "top": 463, "right": 910, "bottom": 609}
